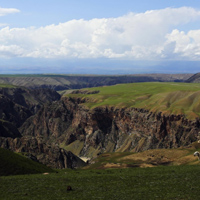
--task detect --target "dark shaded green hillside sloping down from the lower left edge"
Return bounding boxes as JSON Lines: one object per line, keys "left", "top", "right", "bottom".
{"left": 0, "top": 148, "right": 54, "bottom": 176}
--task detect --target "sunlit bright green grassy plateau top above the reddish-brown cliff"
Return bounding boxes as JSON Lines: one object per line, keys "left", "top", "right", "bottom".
{"left": 68, "top": 82, "right": 200, "bottom": 119}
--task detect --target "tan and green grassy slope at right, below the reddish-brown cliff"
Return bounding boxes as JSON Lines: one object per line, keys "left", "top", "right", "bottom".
{"left": 85, "top": 142, "right": 200, "bottom": 169}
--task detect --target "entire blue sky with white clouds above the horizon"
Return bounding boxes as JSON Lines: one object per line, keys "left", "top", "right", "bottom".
{"left": 0, "top": 0, "right": 200, "bottom": 74}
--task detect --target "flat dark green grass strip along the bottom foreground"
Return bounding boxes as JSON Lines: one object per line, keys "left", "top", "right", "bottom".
{"left": 0, "top": 165, "right": 200, "bottom": 200}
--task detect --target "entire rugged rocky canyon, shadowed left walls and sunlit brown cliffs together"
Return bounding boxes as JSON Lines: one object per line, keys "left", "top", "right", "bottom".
{"left": 0, "top": 73, "right": 200, "bottom": 169}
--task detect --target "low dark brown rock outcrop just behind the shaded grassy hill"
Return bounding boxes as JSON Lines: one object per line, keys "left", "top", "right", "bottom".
{"left": 0, "top": 137, "right": 86, "bottom": 169}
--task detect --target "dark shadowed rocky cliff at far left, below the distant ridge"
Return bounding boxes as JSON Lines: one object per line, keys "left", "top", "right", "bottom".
{"left": 0, "top": 88, "right": 60, "bottom": 137}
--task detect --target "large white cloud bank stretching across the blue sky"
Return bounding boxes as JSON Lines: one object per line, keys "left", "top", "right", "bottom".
{"left": 0, "top": 7, "right": 200, "bottom": 60}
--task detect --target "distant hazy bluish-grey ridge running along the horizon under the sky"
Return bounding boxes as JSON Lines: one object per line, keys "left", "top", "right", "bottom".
{"left": 0, "top": 74, "right": 193, "bottom": 91}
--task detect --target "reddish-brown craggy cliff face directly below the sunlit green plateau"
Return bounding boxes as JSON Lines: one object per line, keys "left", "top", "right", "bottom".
{"left": 19, "top": 98, "right": 200, "bottom": 157}
